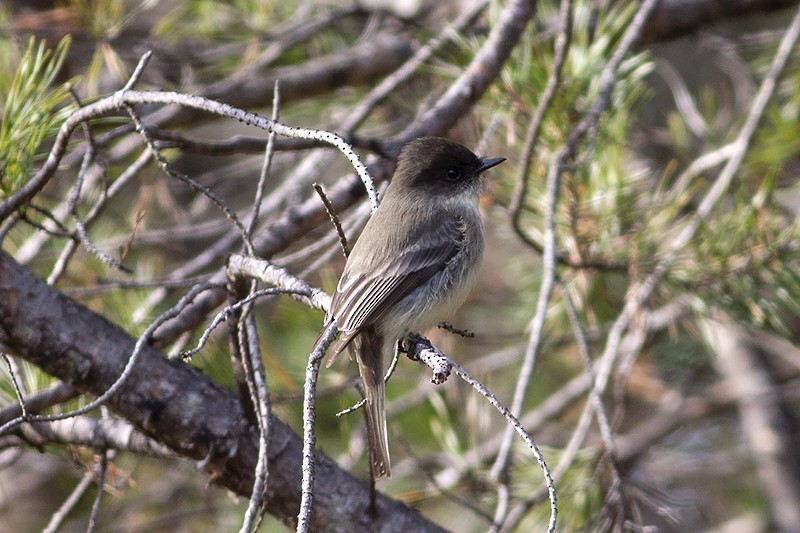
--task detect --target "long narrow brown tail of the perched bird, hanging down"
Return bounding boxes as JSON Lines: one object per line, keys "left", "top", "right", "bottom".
{"left": 351, "top": 328, "right": 392, "bottom": 479}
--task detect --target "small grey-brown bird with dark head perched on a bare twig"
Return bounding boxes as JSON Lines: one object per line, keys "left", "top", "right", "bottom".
{"left": 326, "top": 137, "right": 505, "bottom": 478}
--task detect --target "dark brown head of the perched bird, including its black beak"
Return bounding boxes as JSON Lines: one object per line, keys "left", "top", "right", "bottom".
{"left": 392, "top": 137, "right": 505, "bottom": 191}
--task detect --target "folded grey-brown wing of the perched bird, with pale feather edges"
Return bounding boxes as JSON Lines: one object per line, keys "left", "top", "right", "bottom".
{"left": 330, "top": 218, "right": 464, "bottom": 352}
